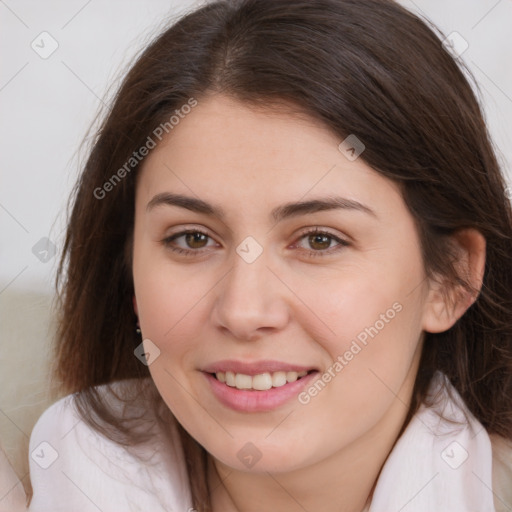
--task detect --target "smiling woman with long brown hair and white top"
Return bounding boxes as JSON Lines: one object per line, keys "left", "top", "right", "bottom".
{"left": 9, "top": 0, "right": 512, "bottom": 512}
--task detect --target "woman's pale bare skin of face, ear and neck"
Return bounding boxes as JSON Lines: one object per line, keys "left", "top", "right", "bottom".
{"left": 133, "top": 95, "right": 485, "bottom": 512}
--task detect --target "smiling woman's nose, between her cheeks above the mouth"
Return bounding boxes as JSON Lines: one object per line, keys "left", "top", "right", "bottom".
{"left": 212, "top": 247, "right": 289, "bottom": 341}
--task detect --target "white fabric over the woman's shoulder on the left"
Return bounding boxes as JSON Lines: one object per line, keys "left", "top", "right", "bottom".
{"left": 29, "top": 380, "right": 189, "bottom": 512}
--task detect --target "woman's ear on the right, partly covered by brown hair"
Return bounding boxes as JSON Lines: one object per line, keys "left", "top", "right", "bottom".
{"left": 423, "top": 228, "right": 486, "bottom": 333}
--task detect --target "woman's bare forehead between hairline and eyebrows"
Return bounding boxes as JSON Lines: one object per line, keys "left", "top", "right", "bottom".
{"left": 138, "top": 95, "right": 400, "bottom": 216}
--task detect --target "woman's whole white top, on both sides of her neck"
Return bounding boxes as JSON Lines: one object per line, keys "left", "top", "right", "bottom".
{"left": 29, "top": 374, "right": 512, "bottom": 512}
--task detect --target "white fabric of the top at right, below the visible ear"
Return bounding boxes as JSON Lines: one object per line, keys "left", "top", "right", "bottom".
{"left": 366, "top": 372, "right": 495, "bottom": 512}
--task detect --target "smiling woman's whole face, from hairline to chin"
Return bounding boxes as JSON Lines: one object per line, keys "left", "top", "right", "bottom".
{"left": 133, "top": 96, "right": 440, "bottom": 471}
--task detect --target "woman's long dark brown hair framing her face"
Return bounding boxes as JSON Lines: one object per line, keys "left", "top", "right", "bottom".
{"left": 51, "top": 0, "right": 512, "bottom": 511}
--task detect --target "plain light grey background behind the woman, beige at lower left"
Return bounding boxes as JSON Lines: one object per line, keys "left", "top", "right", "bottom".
{"left": 0, "top": 0, "right": 512, "bottom": 492}
